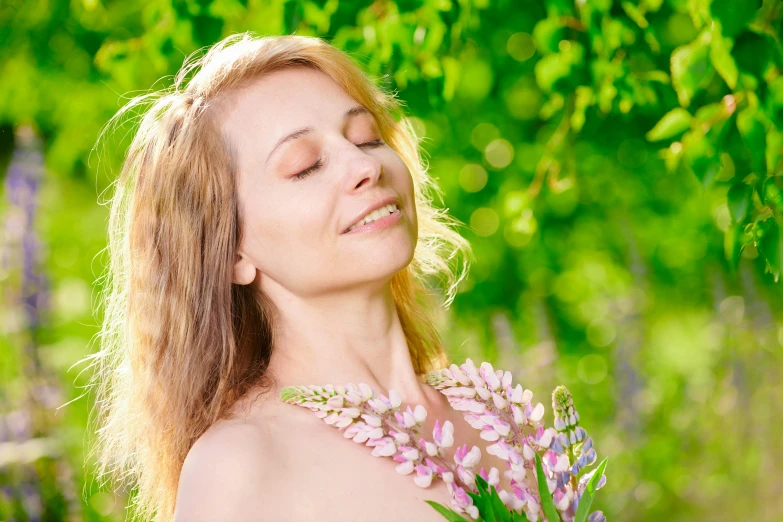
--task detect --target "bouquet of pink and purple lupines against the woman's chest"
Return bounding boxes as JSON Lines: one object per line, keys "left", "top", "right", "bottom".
{"left": 281, "top": 359, "right": 606, "bottom": 522}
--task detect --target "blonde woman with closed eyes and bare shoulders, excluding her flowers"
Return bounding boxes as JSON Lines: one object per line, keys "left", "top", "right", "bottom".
{"left": 86, "top": 34, "right": 504, "bottom": 521}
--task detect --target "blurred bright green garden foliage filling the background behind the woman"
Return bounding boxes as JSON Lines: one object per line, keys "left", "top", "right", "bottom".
{"left": 0, "top": 0, "right": 783, "bottom": 521}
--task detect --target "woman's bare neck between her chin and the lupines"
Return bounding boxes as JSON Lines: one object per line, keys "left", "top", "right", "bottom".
{"left": 264, "top": 274, "right": 437, "bottom": 405}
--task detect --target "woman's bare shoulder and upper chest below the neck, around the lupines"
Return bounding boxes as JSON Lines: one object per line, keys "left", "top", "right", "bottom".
{"left": 175, "top": 372, "right": 508, "bottom": 522}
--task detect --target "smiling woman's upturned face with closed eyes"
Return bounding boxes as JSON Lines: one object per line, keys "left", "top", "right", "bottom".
{"left": 222, "top": 68, "right": 418, "bottom": 296}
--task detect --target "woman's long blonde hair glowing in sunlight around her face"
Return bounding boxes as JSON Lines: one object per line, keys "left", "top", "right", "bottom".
{"left": 88, "top": 33, "right": 471, "bottom": 521}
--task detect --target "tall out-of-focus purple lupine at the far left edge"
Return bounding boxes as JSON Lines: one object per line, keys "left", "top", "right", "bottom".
{"left": 0, "top": 126, "right": 80, "bottom": 520}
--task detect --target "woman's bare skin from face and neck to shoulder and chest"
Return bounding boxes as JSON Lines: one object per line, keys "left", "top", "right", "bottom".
{"left": 175, "top": 69, "right": 506, "bottom": 522}
